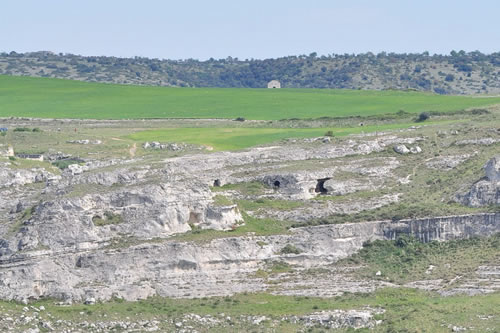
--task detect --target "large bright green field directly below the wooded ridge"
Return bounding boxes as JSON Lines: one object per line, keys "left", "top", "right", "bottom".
{"left": 0, "top": 75, "right": 500, "bottom": 120}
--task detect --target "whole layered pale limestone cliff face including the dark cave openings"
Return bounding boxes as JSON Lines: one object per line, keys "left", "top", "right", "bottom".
{"left": 0, "top": 130, "right": 500, "bottom": 303}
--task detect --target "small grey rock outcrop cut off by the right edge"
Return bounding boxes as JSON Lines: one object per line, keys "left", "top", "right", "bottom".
{"left": 457, "top": 156, "right": 500, "bottom": 207}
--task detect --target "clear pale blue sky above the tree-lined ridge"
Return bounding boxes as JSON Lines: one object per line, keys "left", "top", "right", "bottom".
{"left": 0, "top": 0, "right": 500, "bottom": 60}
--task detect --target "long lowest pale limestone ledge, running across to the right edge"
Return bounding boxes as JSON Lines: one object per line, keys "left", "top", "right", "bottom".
{"left": 0, "top": 213, "right": 500, "bottom": 301}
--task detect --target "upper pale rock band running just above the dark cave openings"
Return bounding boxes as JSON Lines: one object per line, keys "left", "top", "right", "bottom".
{"left": 164, "top": 135, "right": 423, "bottom": 187}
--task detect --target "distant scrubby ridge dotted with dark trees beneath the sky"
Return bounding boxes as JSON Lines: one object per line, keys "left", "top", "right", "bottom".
{"left": 0, "top": 51, "right": 500, "bottom": 94}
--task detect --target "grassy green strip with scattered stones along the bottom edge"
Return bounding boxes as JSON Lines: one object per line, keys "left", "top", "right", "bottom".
{"left": 0, "top": 288, "right": 500, "bottom": 333}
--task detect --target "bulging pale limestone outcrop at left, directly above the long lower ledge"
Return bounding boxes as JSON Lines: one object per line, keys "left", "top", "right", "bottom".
{"left": 3, "top": 181, "right": 243, "bottom": 252}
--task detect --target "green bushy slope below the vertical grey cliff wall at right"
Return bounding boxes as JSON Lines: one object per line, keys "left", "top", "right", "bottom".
{"left": 344, "top": 234, "right": 500, "bottom": 283}
